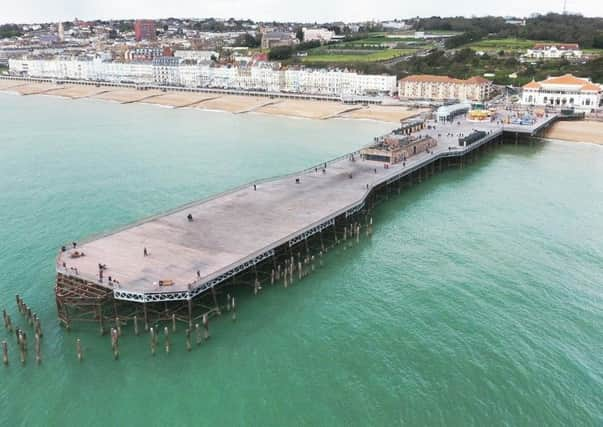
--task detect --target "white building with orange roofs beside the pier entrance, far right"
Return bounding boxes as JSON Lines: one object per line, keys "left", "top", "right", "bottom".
{"left": 521, "top": 74, "right": 603, "bottom": 112}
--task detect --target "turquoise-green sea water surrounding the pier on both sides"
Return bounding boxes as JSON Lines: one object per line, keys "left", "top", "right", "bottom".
{"left": 0, "top": 94, "right": 603, "bottom": 426}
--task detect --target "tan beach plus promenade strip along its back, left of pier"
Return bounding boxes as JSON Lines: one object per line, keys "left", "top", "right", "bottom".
{"left": 0, "top": 76, "right": 422, "bottom": 123}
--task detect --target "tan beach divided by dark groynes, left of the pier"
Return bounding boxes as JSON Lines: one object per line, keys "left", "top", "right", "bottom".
{"left": 0, "top": 80, "right": 425, "bottom": 124}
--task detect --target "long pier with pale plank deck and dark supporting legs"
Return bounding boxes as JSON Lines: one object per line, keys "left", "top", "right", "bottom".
{"left": 55, "top": 108, "right": 558, "bottom": 333}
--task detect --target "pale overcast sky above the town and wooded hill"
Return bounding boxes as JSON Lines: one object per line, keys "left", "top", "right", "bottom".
{"left": 0, "top": 0, "right": 603, "bottom": 24}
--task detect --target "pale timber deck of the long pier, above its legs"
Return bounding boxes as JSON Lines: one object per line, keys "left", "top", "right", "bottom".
{"left": 57, "top": 112, "right": 556, "bottom": 318}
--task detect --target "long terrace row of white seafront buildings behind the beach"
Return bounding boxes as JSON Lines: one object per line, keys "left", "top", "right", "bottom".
{"left": 9, "top": 57, "right": 397, "bottom": 97}
